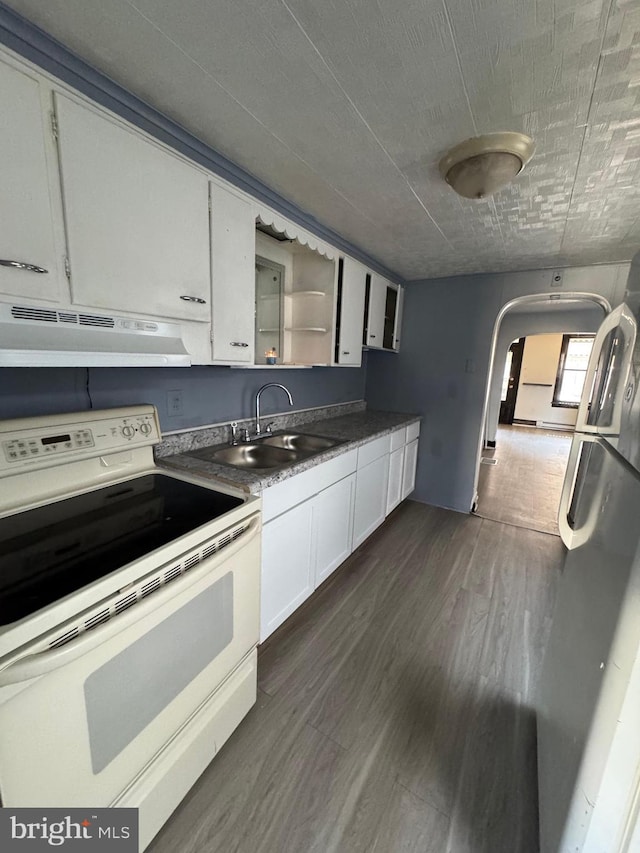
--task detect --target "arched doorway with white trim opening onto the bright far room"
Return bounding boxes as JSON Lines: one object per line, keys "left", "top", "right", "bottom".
{"left": 474, "top": 293, "right": 610, "bottom": 535}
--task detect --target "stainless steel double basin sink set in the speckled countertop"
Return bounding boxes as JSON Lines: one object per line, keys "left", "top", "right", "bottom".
{"left": 191, "top": 432, "right": 344, "bottom": 471}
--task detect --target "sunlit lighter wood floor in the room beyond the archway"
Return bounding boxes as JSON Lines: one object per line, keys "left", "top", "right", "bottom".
{"left": 476, "top": 425, "right": 572, "bottom": 534}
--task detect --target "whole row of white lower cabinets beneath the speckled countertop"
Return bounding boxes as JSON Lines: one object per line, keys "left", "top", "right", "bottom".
{"left": 260, "top": 423, "right": 420, "bottom": 643}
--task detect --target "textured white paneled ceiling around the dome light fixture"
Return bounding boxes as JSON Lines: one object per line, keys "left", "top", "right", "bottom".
{"left": 5, "top": 0, "right": 640, "bottom": 279}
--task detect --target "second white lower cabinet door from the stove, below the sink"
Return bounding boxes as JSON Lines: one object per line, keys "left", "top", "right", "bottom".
{"left": 314, "top": 474, "right": 356, "bottom": 586}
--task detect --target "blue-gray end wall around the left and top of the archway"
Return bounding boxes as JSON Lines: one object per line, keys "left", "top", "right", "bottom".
{"left": 366, "top": 264, "right": 629, "bottom": 512}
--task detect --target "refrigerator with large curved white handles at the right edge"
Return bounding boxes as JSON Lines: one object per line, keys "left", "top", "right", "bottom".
{"left": 537, "top": 254, "right": 640, "bottom": 853}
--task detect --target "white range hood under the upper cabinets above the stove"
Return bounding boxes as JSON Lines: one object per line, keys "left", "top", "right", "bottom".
{"left": 0, "top": 303, "right": 191, "bottom": 367}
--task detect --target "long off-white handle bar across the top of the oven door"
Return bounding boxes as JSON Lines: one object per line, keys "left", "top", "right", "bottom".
{"left": 0, "top": 521, "right": 261, "bottom": 687}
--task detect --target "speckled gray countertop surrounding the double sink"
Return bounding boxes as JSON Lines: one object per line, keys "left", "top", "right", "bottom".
{"left": 156, "top": 410, "right": 420, "bottom": 494}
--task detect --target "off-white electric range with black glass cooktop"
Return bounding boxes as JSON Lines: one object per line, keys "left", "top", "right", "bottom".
{"left": 0, "top": 406, "right": 261, "bottom": 850}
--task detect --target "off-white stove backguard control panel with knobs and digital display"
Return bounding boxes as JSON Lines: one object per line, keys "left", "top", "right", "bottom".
{"left": 0, "top": 406, "right": 161, "bottom": 473}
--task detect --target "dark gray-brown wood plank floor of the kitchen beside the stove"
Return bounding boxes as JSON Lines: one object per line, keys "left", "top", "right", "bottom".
{"left": 149, "top": 501, "right": 562, "bottom": 853}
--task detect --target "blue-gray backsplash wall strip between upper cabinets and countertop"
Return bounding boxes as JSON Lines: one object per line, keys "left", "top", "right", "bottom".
{"left": 0, "top": 358, "right": 366, "bottom": 432}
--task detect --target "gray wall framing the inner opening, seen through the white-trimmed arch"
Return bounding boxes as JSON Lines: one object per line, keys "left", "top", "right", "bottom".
{"left": 486, "top": 306, "right": 604, "bottom": 441}
